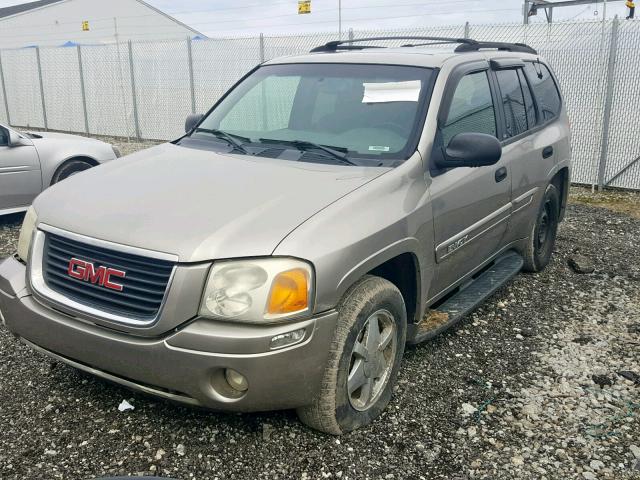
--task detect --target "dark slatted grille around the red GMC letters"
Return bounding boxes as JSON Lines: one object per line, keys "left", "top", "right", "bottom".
{"left": 42, "top": 232, "right": 175, "bottom": 320}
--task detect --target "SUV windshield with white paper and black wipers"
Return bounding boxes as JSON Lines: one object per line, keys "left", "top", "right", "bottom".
{"left": 190, "top": 63, "right": 433, "bottom": 165}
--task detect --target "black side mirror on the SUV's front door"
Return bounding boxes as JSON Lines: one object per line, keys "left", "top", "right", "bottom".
{"left": 436, "top": 132, "right": 502, "bottom": 168}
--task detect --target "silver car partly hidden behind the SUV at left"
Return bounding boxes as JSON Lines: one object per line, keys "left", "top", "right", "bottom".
{"left": 0, "top": 125, "right": 119, "bottom": 215}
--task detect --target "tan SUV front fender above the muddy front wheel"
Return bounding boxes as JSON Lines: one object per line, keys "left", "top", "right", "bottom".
{"left": 273, "top": 156, "right": 434, "bottom": 312}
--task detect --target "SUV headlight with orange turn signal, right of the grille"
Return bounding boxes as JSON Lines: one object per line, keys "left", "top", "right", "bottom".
{"left": 200, "top": 258, "right": 313, "bottom": 322}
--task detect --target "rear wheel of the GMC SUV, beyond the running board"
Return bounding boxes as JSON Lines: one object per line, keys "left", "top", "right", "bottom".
{"left": 522, "top": 184, "right": 560, "bottom": 272}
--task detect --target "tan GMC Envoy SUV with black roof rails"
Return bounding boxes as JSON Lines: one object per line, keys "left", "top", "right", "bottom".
{"left": 0, "top": 37, "right": 571, "bottom": 434}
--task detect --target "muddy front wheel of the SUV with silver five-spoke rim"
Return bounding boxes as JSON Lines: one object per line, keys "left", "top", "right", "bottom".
{"left": 297, "top": 276, "right": 407, "bottom": 435}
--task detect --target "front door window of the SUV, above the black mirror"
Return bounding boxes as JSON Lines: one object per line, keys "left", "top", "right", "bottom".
{"left": 441, "top": 72, "right": 496, "bottom": 145}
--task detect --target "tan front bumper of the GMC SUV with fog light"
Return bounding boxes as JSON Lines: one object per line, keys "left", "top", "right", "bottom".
{"left": 0, "top": 257, "right": 338, "bottom": 411}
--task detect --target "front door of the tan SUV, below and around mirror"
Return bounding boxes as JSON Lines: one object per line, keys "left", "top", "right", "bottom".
{"left": 430, "top": 61, "right": 511, "bottom": 297}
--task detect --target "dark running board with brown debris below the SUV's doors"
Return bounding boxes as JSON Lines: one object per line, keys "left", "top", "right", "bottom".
{"left": 407, "top": 252, "right": 524, "bottom": 344}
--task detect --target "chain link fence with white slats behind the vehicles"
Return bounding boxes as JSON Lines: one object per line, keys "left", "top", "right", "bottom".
{"left": 0, "top": 18, "right": 640, "bottom": 190}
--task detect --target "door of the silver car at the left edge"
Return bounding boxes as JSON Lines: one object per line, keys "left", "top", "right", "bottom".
{"left": 0, "top": 125, "right": 42, "bottom": 212}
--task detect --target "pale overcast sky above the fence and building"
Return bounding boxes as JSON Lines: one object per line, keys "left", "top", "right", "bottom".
{"left": 0, "top": 0, "right": 626, "bottom": 37}
